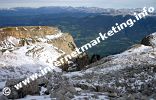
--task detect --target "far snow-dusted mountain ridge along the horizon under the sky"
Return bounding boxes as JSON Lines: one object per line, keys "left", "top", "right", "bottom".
{"left": 0, "top": 6, "right": 156, "bottom": 15}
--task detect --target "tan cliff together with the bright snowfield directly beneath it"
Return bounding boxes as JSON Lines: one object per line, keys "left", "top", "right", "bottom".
{"left": 0, "top": 26, "right": 77, "bottom": 80}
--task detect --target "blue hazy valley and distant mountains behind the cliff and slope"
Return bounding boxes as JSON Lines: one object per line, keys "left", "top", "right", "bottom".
{"left": 0, "top": 7, "right": 156, "bottom": 56}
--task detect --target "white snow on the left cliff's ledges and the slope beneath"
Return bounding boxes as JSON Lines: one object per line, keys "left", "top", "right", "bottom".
{"left": 0, "top": 27, "right": 65, "bottom": 80}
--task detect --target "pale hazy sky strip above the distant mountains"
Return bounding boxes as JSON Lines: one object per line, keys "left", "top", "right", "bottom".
{"left": 0, "top": 0, "right": 156, "bottom": 8}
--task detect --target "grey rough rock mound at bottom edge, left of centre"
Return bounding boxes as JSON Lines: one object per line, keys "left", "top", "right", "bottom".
{"left": 47, "top": 73, "right": 77, "bottom": 100}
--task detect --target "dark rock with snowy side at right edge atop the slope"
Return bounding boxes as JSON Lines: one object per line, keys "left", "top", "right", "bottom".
{"left": 141, "top": 33, "right": 156, "bottom": 47}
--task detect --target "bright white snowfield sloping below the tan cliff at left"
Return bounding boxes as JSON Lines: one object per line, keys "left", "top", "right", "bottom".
{"left": 0, "top": 43, "right": 62, "bottom": 79}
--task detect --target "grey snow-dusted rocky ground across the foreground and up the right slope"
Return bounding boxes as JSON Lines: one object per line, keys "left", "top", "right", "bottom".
{"left": 0, "top": 27, "right": 156, "bottom": 100}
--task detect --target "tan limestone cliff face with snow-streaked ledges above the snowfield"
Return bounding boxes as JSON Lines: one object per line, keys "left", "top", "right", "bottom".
{"left": 0, "top": 26, "right": 76, "bottom": 54}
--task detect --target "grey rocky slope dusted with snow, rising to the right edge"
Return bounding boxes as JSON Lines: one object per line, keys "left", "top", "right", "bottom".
{"left": 63, "top": 33, "right": 156, "bottom": 100}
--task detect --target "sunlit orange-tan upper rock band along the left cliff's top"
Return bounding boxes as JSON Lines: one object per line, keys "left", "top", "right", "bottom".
{"left": 0, "top": 26, "right": 59, "bottom": 40}
